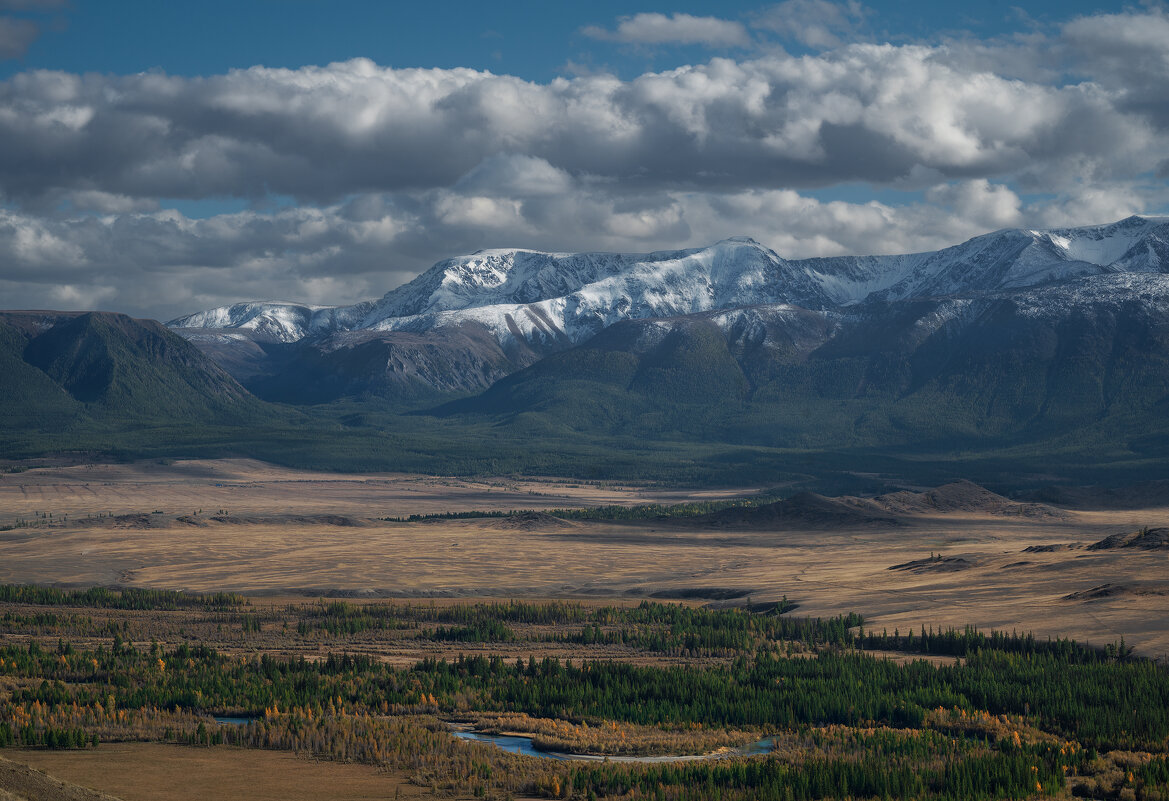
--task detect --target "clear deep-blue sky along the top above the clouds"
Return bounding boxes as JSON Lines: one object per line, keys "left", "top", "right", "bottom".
{"left": 0, "top": 0, "right": 1122, "bottom": 81}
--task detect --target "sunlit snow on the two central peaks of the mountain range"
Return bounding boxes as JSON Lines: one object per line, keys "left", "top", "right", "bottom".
{"left": 353, "top": 237, "right": 823, "bottom": 341}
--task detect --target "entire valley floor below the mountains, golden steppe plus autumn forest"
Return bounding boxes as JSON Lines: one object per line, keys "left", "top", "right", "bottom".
{"left": 0, "top": 460, "right": 1169, "bottom": 801}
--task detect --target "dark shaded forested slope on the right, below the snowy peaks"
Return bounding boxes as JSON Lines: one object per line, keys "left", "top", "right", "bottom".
{"left": 440, "top": 275, "right": 1169, "bottom": 450}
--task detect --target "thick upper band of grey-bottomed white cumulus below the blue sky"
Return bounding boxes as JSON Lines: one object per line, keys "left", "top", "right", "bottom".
{"left": 0, "top": 44, "right": 1165, "bottom": 205}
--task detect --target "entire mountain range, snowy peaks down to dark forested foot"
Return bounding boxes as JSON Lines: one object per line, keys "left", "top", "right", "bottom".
{"left": 0, "top": 216, "right": 1169, "bottom": 483}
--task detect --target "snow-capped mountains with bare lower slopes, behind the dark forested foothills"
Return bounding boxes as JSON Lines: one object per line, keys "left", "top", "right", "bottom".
{"left": 168, "top": 216, "right": 1169, "bottom": 401}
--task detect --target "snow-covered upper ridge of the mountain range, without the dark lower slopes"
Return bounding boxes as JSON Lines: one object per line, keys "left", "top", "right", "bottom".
{"left": 168, "top": 216, "right": 1169, "bottom": 344}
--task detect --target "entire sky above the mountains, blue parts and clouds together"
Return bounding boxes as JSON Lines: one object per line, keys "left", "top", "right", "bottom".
{"left": 0, "top": 0, "right": 1169, "bottom": 319}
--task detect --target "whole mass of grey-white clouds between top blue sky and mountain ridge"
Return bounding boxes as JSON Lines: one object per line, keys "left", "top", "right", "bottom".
{"left": 0, "top": 8, "right": 1169, "bottom": 317}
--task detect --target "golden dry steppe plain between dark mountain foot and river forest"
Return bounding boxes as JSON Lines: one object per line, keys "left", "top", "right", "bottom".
{"left": 0, "top": 460, "right": 1169, "bottom": 657}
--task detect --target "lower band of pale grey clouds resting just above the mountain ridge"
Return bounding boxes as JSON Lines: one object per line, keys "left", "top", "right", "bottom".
{"left": 0, "top": 173, "right": 1140, "bottom": 319}
